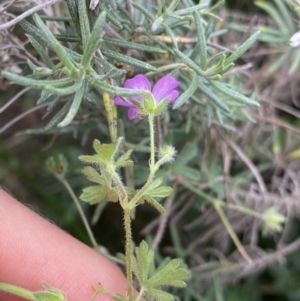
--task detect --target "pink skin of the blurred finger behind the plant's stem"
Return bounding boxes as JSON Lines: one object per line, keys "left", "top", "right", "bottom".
{"left": 0, "top": 189, "right": 126, "bottom": 301}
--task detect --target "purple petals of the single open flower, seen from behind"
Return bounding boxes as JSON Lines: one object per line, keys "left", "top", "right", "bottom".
{"left": 114, "top": 74, "right": 179, "bottom": 119}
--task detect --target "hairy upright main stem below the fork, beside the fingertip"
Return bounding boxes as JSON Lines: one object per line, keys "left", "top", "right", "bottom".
{"left": 123, "top": 203, "right": 132, "bottom": 301}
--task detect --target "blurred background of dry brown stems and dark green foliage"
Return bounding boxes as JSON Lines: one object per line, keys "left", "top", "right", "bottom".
{"left": 0, "top": 0, "right": 300, "bottom": 301}
